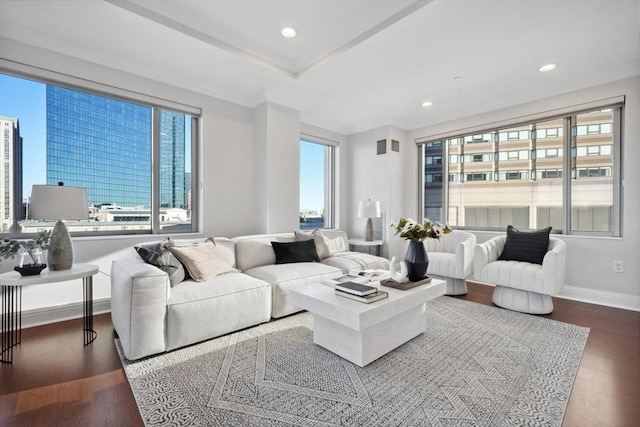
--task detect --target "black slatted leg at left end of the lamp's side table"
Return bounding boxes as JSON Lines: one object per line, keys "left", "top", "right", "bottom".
{"left": 0, "top": 286, "right": 22, "bottom": 363}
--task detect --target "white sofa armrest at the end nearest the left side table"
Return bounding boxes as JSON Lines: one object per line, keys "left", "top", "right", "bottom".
{"left": 111, "top": 257, "right": 171, "bottom": 360}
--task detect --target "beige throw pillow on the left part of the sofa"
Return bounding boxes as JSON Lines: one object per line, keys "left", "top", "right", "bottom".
{"left": 167, "top": 240, "right": 233, "bottom": 282}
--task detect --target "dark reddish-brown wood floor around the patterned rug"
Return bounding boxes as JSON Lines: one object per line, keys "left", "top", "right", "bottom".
{"left": 0, "top": 283, "right": 640, "bottom": 427}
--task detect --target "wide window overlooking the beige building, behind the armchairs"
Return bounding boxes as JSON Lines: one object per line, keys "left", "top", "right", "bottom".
{"left": 418, "top": 104, "right": 622, "bottom": 236}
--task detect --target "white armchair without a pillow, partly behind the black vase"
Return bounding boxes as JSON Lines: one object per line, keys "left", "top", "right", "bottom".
{"left": 425, "top": 230, "right": 476, "bottom": 295}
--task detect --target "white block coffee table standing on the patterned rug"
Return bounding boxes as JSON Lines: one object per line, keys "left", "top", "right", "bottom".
{"left": 289, "top": 279, "right": 446, "bottom": 366}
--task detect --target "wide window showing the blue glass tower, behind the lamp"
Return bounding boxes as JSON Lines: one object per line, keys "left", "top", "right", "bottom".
{"left": 0, "top": 74, "right": 198, "bottom": 237}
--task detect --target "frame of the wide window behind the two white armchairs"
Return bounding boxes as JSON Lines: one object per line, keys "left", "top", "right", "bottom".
{"left": 414, "top": 96, "right": 625, "bottom": 237}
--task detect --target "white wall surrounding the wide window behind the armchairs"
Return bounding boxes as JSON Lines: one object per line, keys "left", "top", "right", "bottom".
{"left": 404, "top": 77, "right": 640, "bottom": 310}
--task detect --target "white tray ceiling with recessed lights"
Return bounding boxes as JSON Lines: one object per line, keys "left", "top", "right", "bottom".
{"left": 0, "top": 0, "right": 640, "bottom": 134}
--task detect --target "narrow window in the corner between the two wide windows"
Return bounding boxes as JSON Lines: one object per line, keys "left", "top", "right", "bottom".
{"left": 300, "top": 140, "right": 335, "bottom": 230}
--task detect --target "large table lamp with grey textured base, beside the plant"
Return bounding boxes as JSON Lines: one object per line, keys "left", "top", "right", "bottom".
{"left": 29, "top": 182, "right": 89, "bottom": 271}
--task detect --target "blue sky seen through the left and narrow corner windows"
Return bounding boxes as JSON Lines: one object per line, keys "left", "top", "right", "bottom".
{"left": 0, "top": 73, "right": 324, "bottom": 211}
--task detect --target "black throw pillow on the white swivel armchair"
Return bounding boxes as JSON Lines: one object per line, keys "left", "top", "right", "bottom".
{"left": 498, "top": 225, "right": 551, "bottom": 265}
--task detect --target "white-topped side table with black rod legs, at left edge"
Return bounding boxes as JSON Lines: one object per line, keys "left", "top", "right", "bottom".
{"left": 0, "top": 264, "right": 99, "bottom": 363}
